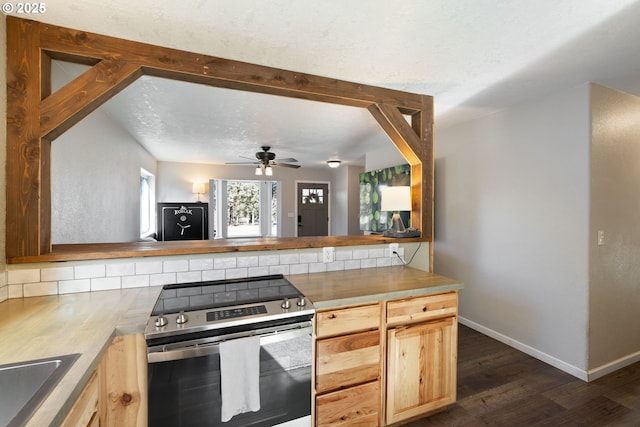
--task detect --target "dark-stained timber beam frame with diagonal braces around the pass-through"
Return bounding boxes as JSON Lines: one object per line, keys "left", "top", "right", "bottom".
{"left": 6, "top": 16, "right": 433, "bottom": 263}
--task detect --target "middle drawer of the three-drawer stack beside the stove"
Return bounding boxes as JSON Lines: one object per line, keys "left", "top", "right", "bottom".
{"left": 316, "top": 330, "right": 380, "bottom": 393}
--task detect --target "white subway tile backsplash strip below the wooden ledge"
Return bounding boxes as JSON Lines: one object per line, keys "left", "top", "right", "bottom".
{"left": 6, "top": 245, "right": 424, "bottom": 301}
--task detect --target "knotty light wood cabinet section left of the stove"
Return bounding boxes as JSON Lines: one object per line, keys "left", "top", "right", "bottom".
{"left": 61, "top": 334, "right": 147, "bottom": 427}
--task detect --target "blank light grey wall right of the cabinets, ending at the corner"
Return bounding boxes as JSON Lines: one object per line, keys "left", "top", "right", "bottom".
{"left": 433, "top": 84, "right": 590, "bottom": 376}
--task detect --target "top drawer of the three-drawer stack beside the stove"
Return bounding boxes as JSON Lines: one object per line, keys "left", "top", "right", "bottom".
{"left": 316, "top": 304, "right": 380, "bottom": 338}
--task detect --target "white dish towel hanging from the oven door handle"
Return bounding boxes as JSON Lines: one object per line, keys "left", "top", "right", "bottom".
{"left": 220, "top": 337, "right": 260, "bottom": 422}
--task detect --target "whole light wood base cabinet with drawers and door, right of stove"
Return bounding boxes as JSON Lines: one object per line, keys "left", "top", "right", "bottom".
{"left": 314, "top": 291, "right": 458, "bottom": 427}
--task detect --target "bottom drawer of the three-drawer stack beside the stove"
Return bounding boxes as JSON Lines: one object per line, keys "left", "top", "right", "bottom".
{"left": 316, "top": 381, "right": 380, "bottom": 427}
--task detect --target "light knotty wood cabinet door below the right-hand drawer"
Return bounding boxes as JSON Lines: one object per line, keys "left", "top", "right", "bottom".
{"left": 387, "top": 317, "right": 458, "bottom": 424}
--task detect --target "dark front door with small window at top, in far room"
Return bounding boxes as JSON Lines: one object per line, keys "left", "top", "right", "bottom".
{"left": 298, "top": 182, "right": 329, "bottom": 237}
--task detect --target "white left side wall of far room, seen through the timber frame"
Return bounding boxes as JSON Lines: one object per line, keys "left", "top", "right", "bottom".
{"left": 51, "top": 110, "right": 155, "bottom": 244}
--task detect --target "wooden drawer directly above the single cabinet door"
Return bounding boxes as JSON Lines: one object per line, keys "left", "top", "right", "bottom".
{"left": 387, "top": 292, "right": 458, "bottom": 326}
